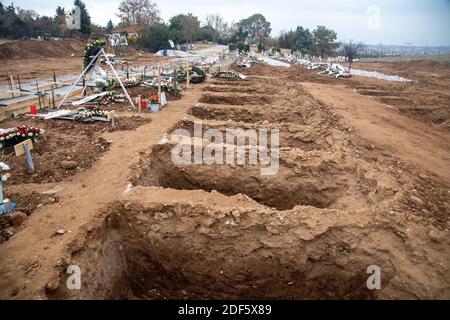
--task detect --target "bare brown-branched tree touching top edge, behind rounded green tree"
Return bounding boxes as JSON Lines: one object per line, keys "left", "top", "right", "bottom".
{"left": 117, "top": 0, "right": 161, "bottom": 26}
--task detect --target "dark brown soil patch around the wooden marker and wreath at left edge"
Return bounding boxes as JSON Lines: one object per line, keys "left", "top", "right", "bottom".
{"left": 2, "top": 116, "right": 150, "bottom": 185}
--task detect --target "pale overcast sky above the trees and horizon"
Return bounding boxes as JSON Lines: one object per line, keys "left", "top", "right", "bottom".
{"left": 6, "top": 0, "right": 450, "bottom": 45}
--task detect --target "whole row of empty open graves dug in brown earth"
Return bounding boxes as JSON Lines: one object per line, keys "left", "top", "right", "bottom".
{"left": 31, "top": 63, "right": 450, "bottom": 299}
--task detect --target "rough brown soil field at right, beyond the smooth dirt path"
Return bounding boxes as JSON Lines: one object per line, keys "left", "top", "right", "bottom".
{"left": 295, "top": 60, "right": 450, "bottom": 130}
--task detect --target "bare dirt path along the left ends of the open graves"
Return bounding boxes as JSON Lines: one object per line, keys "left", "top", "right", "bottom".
{"left": 0, "top": 85, "right": 202, "bottom": 299}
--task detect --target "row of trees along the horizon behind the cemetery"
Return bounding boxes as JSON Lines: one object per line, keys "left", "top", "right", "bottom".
{"left": 0, "top": 0, "right": 356, "bottom": 57}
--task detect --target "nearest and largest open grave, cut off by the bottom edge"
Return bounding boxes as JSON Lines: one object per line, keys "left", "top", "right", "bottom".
{"left": 51, "top": 193, "right": 450, "bottom": 299}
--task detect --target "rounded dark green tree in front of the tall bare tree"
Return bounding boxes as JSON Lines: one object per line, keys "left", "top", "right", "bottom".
{"left": 138, "top": 23, "right": 173, "bottom": 52}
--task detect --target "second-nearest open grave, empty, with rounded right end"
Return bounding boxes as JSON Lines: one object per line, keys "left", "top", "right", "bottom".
{"left": 133, "top": 144, "right": 398, "bottom": 210}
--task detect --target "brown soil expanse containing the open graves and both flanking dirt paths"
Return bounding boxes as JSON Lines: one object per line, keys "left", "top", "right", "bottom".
{"left": 0, "top": 65, "right": 450, "bottom": 299}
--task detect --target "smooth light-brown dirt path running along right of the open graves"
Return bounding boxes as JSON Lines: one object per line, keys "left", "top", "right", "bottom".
{"left": 302, "top": 82, "right": 450, "bottom": 180}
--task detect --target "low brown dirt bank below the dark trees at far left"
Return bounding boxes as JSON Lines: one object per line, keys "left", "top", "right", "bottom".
{"left": 0, "top": 40, "right": 86, "bottom": 59}
